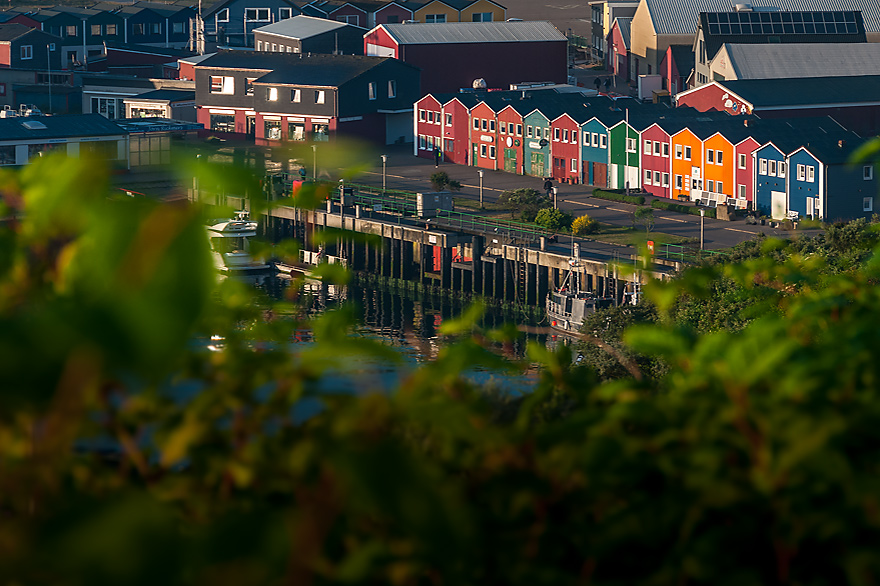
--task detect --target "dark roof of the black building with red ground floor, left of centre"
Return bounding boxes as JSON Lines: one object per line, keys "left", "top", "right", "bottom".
{"left": 196, "top": 51, "right": 416, "bottom": 87}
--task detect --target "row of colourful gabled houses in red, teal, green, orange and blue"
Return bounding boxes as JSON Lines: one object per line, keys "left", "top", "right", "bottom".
{"left": 413, "top": 89, "right": 877, "bottom": 220}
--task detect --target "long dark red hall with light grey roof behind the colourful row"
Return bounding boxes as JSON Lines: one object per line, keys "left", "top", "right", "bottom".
{"left": 364, "top": 21, "right": 568, "bottom": 94}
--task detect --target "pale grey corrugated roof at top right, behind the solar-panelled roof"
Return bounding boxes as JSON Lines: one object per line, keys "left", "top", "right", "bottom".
{"left": 643, "top": 0, "right": 880, "bottom": 35}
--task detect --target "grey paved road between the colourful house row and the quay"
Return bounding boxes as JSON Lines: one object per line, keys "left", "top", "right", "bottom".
{"left": 357, "top": 146, "right": 808, "bottom": 249}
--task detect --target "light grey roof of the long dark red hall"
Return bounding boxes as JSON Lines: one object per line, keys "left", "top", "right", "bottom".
{"left": 374, "top": 20, "right": 567, "bottom": 45}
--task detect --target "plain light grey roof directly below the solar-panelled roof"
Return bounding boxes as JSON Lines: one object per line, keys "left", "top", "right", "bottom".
{"left": 724, "top": 43, "right": 880, "bottom": 80}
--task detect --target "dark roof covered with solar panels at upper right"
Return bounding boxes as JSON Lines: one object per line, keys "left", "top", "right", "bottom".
{"left": 700, "top": 11, "right": 867, "bottom": 59}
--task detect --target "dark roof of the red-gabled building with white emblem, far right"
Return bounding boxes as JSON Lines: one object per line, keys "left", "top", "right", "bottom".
{"left": 716, "top": 75, "right": 880, "bottom": 109}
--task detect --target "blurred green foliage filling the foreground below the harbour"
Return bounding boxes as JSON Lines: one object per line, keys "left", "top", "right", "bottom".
{"left": 12, "top": 157, "right": 880, "bottom": 586}
